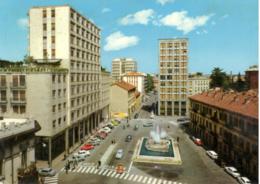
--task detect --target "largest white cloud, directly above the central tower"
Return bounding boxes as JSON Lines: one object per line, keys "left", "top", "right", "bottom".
{"left": 160, "top": 11, "right": 213, "bottom": 34}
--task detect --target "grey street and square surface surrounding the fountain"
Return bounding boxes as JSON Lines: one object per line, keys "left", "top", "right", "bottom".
{"left": 45, "top": 93, "right": 237, "bottom": 184}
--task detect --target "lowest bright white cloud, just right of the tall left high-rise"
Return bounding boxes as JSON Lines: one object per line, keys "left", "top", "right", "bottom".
{"left": 104, "top": 31, "right": 139, "bottom": 51}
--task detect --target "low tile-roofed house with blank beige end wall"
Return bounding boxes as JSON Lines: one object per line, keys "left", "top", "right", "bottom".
{"left": 110, "top": 81, "right": 140, "bottom": 117}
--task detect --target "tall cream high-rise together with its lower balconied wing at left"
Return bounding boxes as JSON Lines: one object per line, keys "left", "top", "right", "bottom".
{"left": 0, "top": 5, "right": 102, "bottom": 165}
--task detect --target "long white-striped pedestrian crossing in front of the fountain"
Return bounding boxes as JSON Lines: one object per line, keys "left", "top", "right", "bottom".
{"left": 61, "top": 165, "right": 182, "bottom": 184}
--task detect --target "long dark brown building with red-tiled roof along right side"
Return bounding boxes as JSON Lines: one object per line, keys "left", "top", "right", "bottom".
{"left": 189, "top": 89, "right": 258, "bottom": 178}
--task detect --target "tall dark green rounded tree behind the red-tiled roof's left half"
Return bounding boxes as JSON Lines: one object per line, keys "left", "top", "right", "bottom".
{"left": 210, "top": 67, "right": 230, "bottom": 89}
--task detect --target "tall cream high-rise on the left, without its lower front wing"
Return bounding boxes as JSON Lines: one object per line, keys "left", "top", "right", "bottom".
{"left": 29, "top": 5, "right": 102, "bottom": 164}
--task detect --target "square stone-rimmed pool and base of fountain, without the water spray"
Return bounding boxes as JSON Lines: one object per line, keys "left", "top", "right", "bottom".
{"left": 132, "top": 137, "right": 182, "bottom": 165}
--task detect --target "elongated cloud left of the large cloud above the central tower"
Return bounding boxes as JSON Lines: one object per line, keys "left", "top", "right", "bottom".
{"left": 119, "top": 9, "right": 155, "bottom": 25}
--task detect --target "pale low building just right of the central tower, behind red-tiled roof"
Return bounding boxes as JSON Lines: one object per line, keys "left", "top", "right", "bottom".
{"left": 189, "top": 75, "right": 210, "bottom": 96}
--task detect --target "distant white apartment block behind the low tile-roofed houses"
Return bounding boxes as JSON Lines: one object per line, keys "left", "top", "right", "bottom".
{"left": 112, "top": 58, "right": 137, "bottom": 81}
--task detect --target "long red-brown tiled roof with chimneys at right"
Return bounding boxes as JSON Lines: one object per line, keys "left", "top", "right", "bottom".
{"left": 189, "top": 89, "right": 258, "bottom": 119}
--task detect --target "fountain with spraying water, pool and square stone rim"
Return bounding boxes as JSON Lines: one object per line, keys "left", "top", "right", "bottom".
{"left": 133, "top": 125, "right": 182, "bottom": 165}
